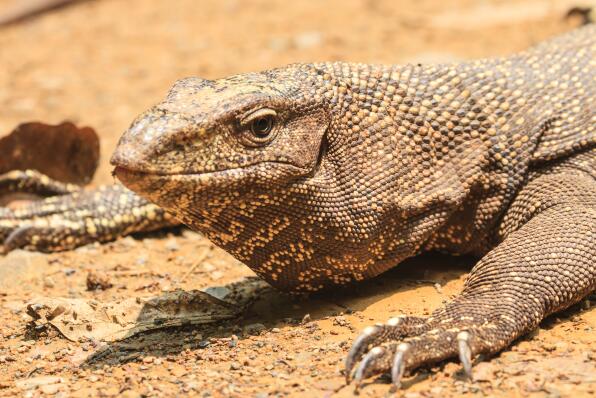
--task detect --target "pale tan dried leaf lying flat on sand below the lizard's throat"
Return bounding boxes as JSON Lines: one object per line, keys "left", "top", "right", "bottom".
{"left": 27, "top": 278, "right": 268, "bottom": 342}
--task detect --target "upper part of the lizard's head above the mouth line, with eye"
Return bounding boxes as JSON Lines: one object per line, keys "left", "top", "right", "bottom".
{"left": 111, "top": 66, "right": 329, "bottom": 179}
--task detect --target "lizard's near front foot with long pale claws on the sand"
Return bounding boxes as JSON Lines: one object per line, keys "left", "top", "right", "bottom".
{"left": 345, "top": 297, "right": 537, "bottom": 390}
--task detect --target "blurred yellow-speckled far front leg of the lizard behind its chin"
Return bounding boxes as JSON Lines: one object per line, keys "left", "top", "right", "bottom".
{"left": 0, "top": 172, "right": 178, "bottom": 252}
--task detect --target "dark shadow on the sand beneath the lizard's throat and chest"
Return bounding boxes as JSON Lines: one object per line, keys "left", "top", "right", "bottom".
{"left": 82, "top": 253, "right": 475, "bottom": 369}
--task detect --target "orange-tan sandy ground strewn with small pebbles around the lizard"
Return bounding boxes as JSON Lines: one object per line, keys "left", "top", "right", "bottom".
{"left": 0, "top": 0, "right": 596, "bottom": 398}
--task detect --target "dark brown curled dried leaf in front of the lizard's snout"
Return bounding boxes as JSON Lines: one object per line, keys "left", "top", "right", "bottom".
{"left": 0, "top": 122, "right": 99, "bottom": 185}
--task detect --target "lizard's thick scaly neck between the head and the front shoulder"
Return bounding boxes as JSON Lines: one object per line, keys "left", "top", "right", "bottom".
{"left": 313, "top": 55, "right": 545, "bottom": 262}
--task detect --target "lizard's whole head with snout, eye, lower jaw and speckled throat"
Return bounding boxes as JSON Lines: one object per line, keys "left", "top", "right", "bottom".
{"left": 111, "top": 65, "right": 338, "bottom": 290}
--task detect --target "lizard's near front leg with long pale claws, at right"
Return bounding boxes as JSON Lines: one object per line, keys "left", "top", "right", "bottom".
{"left": 346, "top": 172, "right": 596, "bottom": 386}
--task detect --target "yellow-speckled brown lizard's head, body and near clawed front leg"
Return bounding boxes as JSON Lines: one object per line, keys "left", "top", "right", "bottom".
{"left": 1, "top": 26, "right": 596, "bottom": 384}
